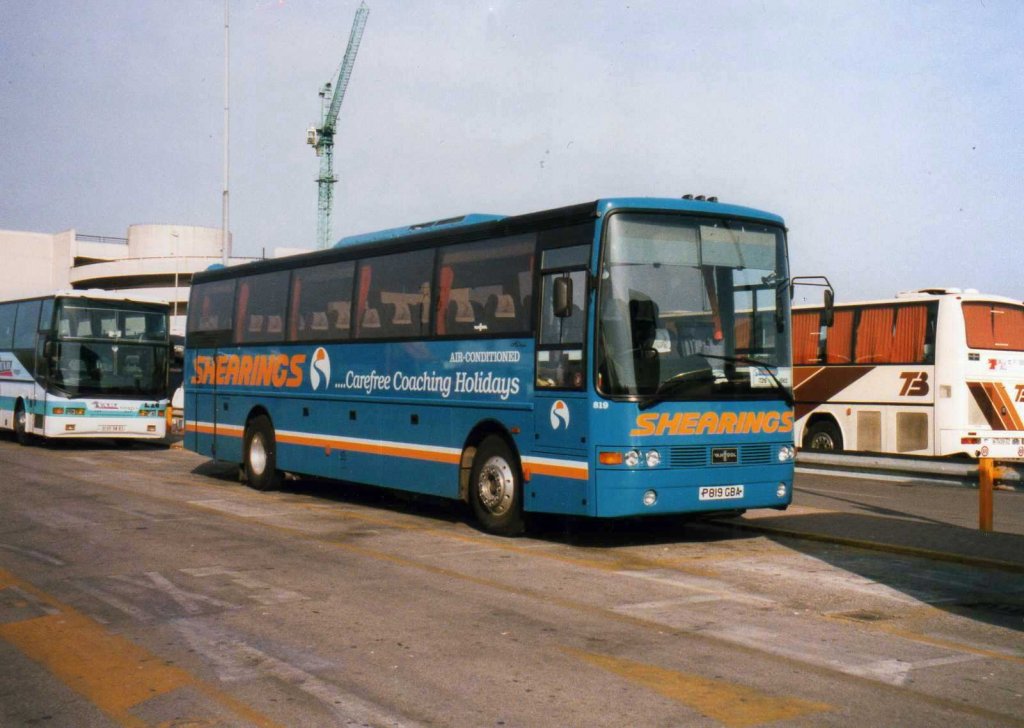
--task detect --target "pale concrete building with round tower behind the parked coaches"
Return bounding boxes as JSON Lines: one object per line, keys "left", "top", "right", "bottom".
{"left": 0, "top": 225, "right": 304, "bottom": 335}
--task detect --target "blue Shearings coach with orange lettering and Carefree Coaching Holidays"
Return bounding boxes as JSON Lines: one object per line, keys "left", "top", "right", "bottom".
{"left": 185, "top": 196, "right": 795, "bottom": 534}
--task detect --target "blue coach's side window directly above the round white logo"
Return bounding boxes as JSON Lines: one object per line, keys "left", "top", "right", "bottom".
{"left": 288, "top": 262, "right": 355, "bottom": 341}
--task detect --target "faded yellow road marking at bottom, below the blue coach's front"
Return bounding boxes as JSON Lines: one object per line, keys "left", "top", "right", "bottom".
{"left": 562, "top": 647, "right": 835, "bottom": 728}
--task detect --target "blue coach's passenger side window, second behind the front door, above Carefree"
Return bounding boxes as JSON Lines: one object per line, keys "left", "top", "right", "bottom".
{"left": 354, "top": 250, "right": 434, "bottom": 339}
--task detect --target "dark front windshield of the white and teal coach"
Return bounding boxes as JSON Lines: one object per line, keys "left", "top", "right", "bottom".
{"left": 48, "top": 300, "right": 168, "bottom": 398}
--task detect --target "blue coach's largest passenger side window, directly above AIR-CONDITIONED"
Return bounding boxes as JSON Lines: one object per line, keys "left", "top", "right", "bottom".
{"left": 436, "top": 234, "right": 535, "bottom": 336}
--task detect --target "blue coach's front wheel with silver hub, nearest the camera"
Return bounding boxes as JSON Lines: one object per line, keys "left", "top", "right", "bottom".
{"left": 469, "top": 435, "right": 524, "bottom": 536}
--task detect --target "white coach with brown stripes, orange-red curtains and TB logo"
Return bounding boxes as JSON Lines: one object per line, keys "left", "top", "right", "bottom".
{"left": 793, "top": 289, "right": 1024, "bottom": 459}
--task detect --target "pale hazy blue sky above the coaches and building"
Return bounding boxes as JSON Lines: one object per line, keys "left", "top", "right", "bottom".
{"left": 0, "top": 0, "right": 1024, "bottom": 302}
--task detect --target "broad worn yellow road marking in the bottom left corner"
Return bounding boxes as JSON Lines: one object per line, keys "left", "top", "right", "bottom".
{"left": 0, "top": 569, "right": 279, "bottom": 728}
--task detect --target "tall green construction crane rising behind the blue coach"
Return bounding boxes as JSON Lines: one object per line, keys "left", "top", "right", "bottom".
{"left": 306, "top": 2, "right": 370, "bottom": 248}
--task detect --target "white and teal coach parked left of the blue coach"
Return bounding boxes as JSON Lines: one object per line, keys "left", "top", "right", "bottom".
{"left": 0, "top": 290, "right": 169, "bottom": 444}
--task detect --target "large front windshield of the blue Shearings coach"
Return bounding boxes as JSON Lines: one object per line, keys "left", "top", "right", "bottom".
{"left": 597, "top": 214, "right": 792, "bottom": 401}
